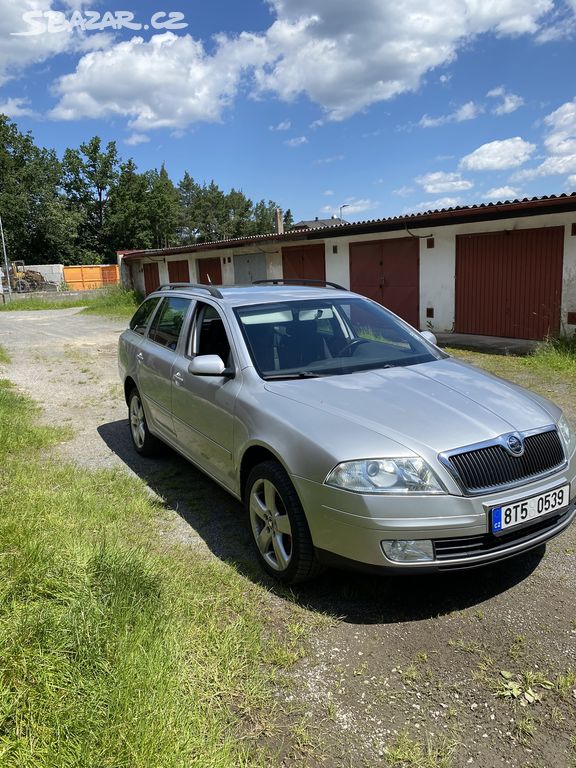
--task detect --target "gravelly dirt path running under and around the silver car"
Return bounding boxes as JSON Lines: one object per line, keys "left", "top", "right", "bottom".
{"left": 0, "top": 309, "right": 576, "bottom": 768}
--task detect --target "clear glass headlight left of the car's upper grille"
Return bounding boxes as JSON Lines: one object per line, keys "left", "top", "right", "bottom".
{"left": 324, "top": 456, "right": 446, "bottom": 493}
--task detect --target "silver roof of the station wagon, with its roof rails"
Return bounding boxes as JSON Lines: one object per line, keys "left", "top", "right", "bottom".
{"left": 154, "top": 283, "right": 356, "bottom": 307}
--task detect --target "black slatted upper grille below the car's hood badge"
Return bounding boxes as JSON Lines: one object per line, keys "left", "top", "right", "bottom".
{"left": 447, "top": 429, "right": 565, "bottom": 493}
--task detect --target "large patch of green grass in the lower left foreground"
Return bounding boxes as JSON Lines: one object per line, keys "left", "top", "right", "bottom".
{"left": 0, "top": 381, "right": 281, "bottom": 768}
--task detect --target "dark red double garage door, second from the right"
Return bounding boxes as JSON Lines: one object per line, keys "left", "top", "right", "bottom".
{"left": 350, "top": 237, "right": 420, "bottom": 328}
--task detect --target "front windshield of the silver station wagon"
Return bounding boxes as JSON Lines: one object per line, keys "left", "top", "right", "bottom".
{"left": 235, "top": 297, "right": 446, "bottom": 379}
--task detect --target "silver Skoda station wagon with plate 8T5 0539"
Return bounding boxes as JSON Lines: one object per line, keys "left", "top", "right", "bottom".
{"left": 119, "top": 281, "right": 576, "bottom": 583}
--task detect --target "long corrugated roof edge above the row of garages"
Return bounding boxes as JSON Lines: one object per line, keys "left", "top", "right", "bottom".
{"left": 117, "top": 192, "right": 576, "bottom": 261}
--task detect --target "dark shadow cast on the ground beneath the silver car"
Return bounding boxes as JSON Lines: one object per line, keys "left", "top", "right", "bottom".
{"left": 98, "top": 420, "right": 545, "bottom": 624}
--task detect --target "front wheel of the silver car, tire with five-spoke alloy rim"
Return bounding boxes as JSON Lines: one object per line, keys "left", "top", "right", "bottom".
{"left": 245, "top": 461, "right": 322, "bottom": 584}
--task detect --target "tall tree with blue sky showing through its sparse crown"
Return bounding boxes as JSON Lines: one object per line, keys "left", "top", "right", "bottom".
{"left": 62, "top": 136, "right": 119, "bottom": 262}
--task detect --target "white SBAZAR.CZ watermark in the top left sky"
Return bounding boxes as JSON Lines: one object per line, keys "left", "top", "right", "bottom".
{"left": 10, "top": 11, "right": 188, "bottom": 36}
